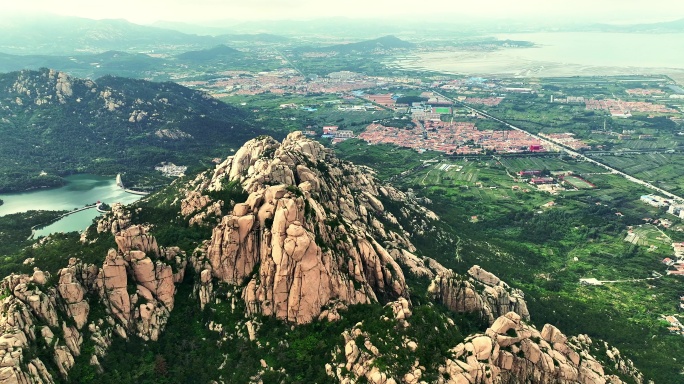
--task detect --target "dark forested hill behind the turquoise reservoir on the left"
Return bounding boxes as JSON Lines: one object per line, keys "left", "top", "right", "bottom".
{"left": 0, "top": 69, "right": 270, "bottom": 192}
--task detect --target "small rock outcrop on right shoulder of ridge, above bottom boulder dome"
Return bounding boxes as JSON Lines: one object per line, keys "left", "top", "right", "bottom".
{"left": 428, "top": 265, "right": 530, "bottom": 324}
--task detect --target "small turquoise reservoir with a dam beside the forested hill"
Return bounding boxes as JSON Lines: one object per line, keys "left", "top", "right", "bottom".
{"left": 0, "top": 174, "right": 142, "bottom": 236}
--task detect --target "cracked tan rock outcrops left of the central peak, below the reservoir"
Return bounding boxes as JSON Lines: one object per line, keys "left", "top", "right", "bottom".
{"left": 0, "top": 226, "right": 187, "bottom": 383}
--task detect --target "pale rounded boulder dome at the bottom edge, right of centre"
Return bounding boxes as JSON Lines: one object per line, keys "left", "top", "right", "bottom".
{"left": 438, "top": 312, "right": 643, "bottom": 384}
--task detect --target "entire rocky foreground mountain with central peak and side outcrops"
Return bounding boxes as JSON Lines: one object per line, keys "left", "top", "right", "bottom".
{"left": 0, "top": 132, "right": 640, "bottom": 384}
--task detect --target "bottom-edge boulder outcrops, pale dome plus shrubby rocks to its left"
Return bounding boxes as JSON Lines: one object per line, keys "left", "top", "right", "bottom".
{"left": 325, "top": 308, "right": 643, "bottom": 384}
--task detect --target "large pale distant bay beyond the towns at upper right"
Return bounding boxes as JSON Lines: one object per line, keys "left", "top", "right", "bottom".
{"left": 394, "top": 32, "right": 684, "bottom": 82}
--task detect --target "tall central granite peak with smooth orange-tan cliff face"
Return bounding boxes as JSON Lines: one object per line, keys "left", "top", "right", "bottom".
{"left": 187, "top": 132, "right": 433, "bottom": 323}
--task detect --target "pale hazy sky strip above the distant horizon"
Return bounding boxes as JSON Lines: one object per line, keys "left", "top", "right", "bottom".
{"left": 0, "top": 0, "right": 684, "bottom": 23}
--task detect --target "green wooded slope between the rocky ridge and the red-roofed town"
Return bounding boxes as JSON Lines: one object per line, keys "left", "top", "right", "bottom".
{"left": 337, "top": 141, "right": 684, "bottom": 383}
